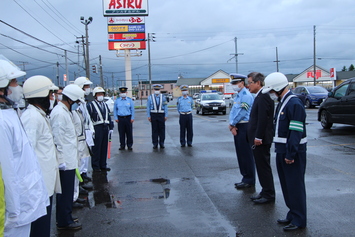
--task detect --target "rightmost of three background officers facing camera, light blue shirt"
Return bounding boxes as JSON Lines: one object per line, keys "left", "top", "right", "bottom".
{"left": 177, "top": 85, "right": 194, "bottom": 147}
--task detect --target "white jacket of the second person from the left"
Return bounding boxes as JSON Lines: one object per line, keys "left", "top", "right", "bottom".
{"left": 21, "top": 105, "right": 61, "bottom": 196}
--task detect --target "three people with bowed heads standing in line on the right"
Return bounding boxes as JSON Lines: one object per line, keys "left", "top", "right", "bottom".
{"left": 229, "top": 72, "right": 307, "bottom": 231}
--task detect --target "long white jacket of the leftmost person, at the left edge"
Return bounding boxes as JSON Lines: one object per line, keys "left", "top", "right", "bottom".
{"left": 0, "top": 108, "right": 49, "bottom": 228}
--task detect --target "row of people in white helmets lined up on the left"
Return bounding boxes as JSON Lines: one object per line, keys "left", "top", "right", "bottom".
{"left": 0, "top": 55, "right": 113, "bottom": 237}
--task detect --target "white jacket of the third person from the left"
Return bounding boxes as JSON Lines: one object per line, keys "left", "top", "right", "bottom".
{"left": 50, "top": 102, "right": 78, "bottom": 170}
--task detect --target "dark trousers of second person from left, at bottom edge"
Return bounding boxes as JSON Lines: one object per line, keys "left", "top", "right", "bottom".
{"left": 30, "top": 196, "right": 53, "bottom": 237}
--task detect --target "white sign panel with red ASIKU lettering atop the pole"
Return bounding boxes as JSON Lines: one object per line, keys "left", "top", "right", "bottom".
{"left": 103, "top": 0, "right": 148, "bottom": 16}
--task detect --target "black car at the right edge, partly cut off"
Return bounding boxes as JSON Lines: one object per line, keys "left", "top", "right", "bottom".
{"left": 318, "top": 77, "right": 355, "bottom": 129}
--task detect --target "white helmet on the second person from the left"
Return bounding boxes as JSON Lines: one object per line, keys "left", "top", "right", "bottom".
{"left": 23, "top": 75, "right": 59, "bottom": 99}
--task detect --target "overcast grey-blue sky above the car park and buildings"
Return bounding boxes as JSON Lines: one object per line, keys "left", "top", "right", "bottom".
{"left": 0, "top": 0, "right": 355, "bottom": 86}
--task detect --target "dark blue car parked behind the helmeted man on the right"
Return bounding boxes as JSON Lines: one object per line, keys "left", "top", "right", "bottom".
{"left": 293, "top": 86, "right": 328, "bottom": 108}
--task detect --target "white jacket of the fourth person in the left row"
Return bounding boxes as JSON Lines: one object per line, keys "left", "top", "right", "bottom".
{"left": 72, "top": 109, "right": 90, "bottom": 159}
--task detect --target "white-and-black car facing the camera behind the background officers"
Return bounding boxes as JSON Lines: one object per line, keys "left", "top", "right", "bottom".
{"left": 195, "top": 93, "right": 226, "bottom": 114}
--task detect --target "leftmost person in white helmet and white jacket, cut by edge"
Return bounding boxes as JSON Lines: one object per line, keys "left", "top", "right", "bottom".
{"left": 0, "top": 55, "right": 49, "bottom": 236}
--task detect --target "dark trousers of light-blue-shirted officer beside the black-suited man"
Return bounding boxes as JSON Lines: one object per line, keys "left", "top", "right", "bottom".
{"left": 234, "top": 123, "right": 255, "bottom": 185}
